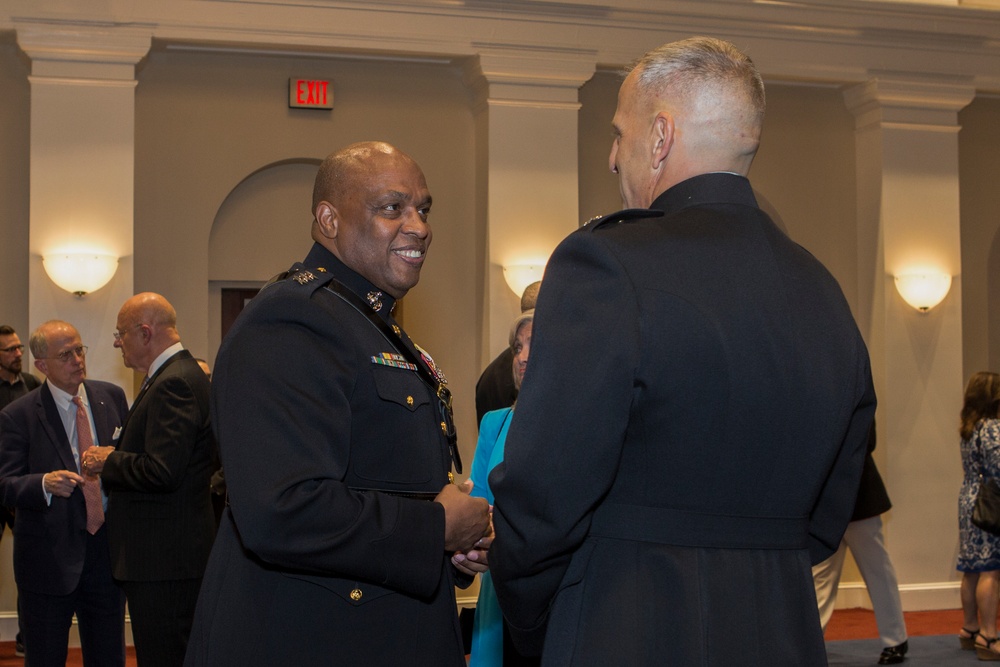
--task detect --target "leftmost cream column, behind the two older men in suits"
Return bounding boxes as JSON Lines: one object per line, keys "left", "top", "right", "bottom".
{"left": 17, "top": 24, "right": 151, "bottom": 394}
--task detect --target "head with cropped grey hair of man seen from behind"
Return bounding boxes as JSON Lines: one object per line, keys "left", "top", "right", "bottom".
{"left": 610, "top": 37, "right": 764, "bottom": 207}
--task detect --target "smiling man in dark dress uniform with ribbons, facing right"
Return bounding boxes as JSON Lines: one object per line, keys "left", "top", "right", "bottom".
{"left": 185, "top": 142, "right": 489, "bottom": 667}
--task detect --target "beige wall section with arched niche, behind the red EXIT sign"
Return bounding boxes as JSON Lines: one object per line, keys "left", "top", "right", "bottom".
{"left": 135, "top": 51, "right": 484, "bottom": 462}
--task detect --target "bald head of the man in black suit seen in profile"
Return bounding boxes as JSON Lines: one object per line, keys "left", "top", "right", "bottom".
{"left": 115, "top": 292, "right": 181, "bottom": 374}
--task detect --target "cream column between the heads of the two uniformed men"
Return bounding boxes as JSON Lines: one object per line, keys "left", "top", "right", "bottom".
{"left": 468, "top": 46, "right": 596, "bottom": 366}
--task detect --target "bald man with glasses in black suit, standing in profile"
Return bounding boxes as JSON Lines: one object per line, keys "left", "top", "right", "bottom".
{"left": 84, "top": 292, "right": 217, "bottom": 667}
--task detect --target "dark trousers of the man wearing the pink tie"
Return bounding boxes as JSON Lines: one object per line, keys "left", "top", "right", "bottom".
{"left": 20, "top": 527, "right": 125, "bottom": 667}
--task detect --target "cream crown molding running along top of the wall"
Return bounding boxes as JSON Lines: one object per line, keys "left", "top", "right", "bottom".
{"left": 0, "top": 0, "right": 1000, "bottom": 93}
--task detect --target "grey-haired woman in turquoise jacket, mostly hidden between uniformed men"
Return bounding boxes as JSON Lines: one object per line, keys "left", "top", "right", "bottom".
{"left": 469, "top": 310, "right": 538, "bottom": 667}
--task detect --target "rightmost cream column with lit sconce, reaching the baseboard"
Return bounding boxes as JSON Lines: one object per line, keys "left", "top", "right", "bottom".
{"left": 845, "top": 75, "right": 974, "bottom": 610}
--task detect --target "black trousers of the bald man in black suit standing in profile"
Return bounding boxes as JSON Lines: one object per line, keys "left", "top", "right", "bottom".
{"left": 120, "top": 578, "right": 201, "bottom": 667}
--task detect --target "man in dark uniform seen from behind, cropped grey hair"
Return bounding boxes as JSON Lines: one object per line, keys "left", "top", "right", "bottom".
{"left": 490, "top": 38, "right": 875, "bottom": 667}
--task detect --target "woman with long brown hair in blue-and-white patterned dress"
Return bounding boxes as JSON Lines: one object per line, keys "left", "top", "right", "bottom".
{"left": 958, "top": 372, "right": 1000, "bottom": 660}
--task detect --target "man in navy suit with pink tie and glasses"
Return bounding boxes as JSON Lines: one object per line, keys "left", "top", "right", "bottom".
{"left": 0, "top": 320, "right": 128, "bottom": 667}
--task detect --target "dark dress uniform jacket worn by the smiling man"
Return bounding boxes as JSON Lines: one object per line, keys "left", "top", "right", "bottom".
{"left": 185, "top": 245, "right": 468, "bottom": 667}
